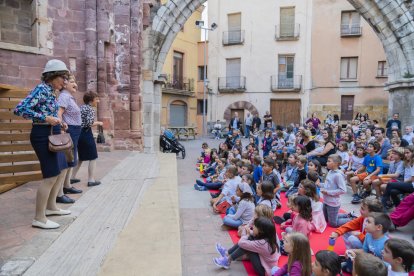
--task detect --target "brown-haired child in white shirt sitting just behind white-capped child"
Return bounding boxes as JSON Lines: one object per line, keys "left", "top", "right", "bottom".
{"left": 210, "top": 166, "right": 241, "bottom": 213}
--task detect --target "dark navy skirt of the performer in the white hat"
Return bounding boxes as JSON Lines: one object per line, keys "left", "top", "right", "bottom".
{"left": 30, "top": 125, "right": 68, "bottom": 178}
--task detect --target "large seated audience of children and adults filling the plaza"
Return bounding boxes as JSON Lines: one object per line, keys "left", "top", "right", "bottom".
{"left": 194, "top": 111, "right": 414, "bottom": 276}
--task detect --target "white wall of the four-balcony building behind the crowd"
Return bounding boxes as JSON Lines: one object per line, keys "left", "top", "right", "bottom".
{"left": 208, "top": 0, "right": 312, "bottom": 124}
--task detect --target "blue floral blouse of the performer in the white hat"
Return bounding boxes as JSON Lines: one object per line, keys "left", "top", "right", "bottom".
{"left": 14, "top": 82, "right": 59, "bottom": 123}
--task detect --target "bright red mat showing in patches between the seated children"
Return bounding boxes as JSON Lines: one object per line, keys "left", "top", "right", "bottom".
{"left": 222, "top": 193, "right": 345, "bottom": 276}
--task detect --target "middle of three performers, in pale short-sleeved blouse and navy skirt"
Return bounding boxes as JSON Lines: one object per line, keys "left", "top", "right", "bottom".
{"left": 56, "top": 74, "right": 82, "bottom": 203}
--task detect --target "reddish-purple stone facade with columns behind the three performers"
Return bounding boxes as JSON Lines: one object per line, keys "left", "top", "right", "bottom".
{"left": 0, "top": 0, "right": 150, "bottom": 150}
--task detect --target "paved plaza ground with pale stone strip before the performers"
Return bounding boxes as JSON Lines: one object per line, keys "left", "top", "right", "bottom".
{"left": 0, "top": 139, "right": 414, "bottom": 275}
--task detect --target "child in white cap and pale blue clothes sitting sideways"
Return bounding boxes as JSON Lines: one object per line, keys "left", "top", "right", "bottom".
{"left": 223, "top": 182, "right": 255, "bottom": 228}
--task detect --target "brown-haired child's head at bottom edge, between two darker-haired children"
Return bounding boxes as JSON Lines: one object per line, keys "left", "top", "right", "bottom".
{"left": 352, "top": 252, "right": 388, "bottom": 276}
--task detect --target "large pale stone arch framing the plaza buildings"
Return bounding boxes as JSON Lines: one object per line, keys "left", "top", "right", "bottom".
{"left": 143, "top": 0, "right": 414, "bottom": 152}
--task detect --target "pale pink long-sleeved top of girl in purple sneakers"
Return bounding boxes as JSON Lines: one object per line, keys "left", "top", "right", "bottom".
{"left": 238, "top": 235, "right": 280, "bottom": 276}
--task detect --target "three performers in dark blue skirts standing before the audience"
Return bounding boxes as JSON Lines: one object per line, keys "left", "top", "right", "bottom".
{"left": 14, "top": 59, "right": 103, "bottom": 229}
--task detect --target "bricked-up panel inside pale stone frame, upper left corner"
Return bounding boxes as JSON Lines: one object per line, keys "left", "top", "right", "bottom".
{"left": 0, "top": 0, "right": 36, "bottom": 46}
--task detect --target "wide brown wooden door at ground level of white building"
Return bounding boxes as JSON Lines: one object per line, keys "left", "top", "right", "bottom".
{"left": 270, "top": 100, "right": 301, "bottom": 126}
